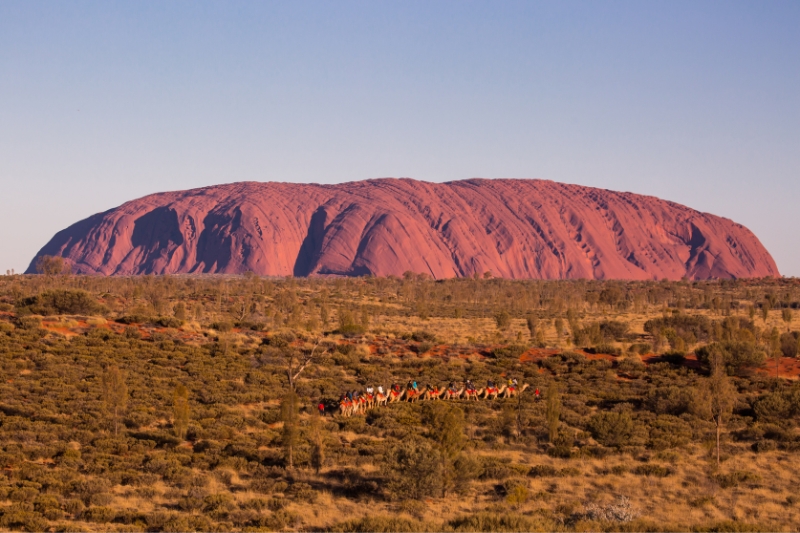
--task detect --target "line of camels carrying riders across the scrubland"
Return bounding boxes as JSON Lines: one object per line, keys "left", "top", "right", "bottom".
{"left": 338, "top": 381, "right": 529, "bottom": 417}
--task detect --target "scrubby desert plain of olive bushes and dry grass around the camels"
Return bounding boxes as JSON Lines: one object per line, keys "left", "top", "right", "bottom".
{"left": 0, "top": 272, "right": 800, "bottom": 531}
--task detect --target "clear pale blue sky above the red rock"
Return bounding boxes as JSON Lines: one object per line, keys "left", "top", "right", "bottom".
{"left": 0, "top": 0, "right": 800, "bottom": 276}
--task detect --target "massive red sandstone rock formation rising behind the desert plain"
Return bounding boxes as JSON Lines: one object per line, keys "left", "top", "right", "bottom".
{"left": 28, "top": 179, "right": 779, "bottom": 280}
